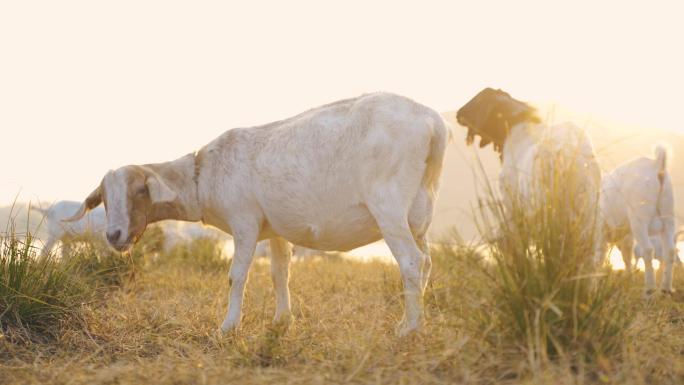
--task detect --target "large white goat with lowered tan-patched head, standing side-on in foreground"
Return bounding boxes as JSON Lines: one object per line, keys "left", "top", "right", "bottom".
{"left": 65, "top": 93, "right": 449, "bottom": 335}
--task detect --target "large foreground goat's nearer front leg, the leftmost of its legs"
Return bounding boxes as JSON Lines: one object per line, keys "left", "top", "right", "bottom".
{"left": 221, "top": 223, "right": 259, "bottom": 333}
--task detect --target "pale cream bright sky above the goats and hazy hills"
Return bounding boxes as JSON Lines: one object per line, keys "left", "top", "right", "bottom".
{"left": 0, "top": 0, "right": 684, "bottom": 204}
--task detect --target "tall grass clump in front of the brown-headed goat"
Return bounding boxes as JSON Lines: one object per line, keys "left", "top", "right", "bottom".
{"left": 472, "top": 148, "right": 633, "bottom": 368}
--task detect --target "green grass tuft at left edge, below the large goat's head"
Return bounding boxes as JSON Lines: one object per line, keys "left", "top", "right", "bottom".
{"left": 0, "top": 207, "right": 154, "bottom": 340}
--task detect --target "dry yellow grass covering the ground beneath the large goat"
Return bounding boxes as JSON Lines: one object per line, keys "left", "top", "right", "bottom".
{"left": 0, "top": 244, "right": 684, "bottom": 384}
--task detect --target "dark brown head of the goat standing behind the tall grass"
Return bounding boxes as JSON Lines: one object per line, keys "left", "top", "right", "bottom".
{"left": 456, "top": 88, "right": 541, "bottom": 156}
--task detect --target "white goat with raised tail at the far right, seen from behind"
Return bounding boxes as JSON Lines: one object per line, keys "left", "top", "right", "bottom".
{"left": 601, "top": 146, "right": 677, "bottom": 293}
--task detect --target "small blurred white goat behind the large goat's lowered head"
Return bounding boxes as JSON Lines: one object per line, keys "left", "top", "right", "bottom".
{"left": 31, "top": 201, "right": 107, "bottom": 256}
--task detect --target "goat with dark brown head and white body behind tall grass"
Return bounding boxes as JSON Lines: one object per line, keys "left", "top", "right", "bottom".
{"left": 456, "top": 88, "right": 601, "bottom": 242}
